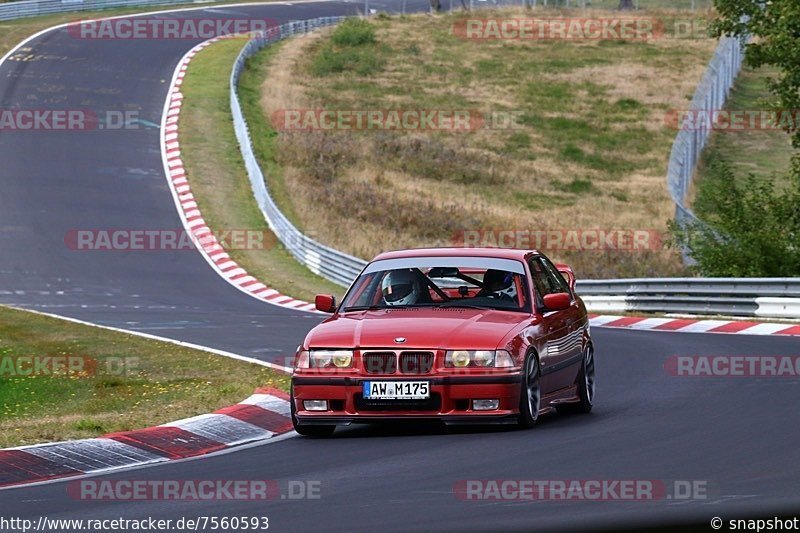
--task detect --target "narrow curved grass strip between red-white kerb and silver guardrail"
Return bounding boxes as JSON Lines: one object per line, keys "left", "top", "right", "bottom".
{"left": 180, "top": 39, "right": 343, "bottom": 301}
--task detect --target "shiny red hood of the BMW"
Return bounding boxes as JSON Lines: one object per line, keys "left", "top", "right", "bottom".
{"left": 305, "top": 308, "right": 529, "bottom": 350}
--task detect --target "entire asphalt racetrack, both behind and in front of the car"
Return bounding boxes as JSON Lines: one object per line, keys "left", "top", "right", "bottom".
{"left": 0, "top": 2, "right": 800, "bottom": 531}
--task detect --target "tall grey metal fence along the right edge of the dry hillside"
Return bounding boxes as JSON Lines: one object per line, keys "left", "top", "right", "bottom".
{"left": 667, "top": 37, "right": 744, "bottom": 238}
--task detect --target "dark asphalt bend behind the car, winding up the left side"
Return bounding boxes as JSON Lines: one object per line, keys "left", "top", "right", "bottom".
{"left": 0, "top": 1, "right": 422, "bottom": 363}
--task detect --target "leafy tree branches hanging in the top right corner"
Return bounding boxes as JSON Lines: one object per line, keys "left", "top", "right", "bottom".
{"left": 711, "top": 0, "right": 800, "bottom": 148}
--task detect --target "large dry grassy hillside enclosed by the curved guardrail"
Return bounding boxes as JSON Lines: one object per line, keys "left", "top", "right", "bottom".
{"left": 250, "top": 10, "right": 716, "bottom": 277}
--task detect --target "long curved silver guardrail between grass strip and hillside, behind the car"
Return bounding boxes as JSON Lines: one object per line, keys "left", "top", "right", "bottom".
{"left": 230, "top": 17, "right": 367, "bottom": 287}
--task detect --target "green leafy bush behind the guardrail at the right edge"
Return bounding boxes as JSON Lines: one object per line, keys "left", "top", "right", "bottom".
{"left": 670, "top": 159, "right": 800, "bottom": 277}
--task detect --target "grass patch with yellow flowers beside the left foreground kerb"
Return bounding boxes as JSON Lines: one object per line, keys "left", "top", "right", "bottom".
{"left": 0, "top": 306, "right": 289, "bottom": 448}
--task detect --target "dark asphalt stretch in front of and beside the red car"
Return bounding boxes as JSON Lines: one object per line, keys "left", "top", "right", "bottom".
{"left": 0, "top": 329, "right": 800, "bottom": 531}
